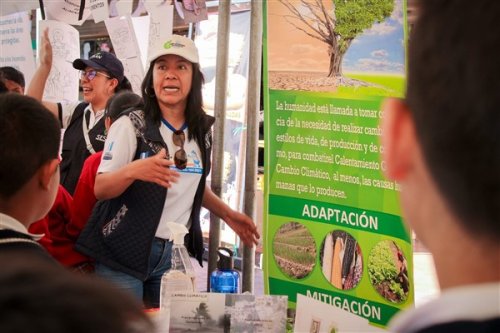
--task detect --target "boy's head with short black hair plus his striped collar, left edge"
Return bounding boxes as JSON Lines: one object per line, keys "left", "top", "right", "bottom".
{"left": 0, "top": 93, "right": 61, "bottom": 257}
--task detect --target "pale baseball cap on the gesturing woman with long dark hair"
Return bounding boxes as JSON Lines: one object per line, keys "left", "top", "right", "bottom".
{"left": 148, "top": 35, "right": 199, "bottom": 63}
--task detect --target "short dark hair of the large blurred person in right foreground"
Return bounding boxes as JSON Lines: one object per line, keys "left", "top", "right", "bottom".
{"left": 405, "top": 0, "right": 500, "bottom": 244}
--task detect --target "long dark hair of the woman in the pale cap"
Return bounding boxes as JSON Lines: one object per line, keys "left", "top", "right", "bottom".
{"left": 141, "top": 60, "right": 205, "bottom": 144}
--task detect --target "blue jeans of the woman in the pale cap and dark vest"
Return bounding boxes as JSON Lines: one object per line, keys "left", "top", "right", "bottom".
{"left": 95, "top": 238, "right": 172, "bottom": 308}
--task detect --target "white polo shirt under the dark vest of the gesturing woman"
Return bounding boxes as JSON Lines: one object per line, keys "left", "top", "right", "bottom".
{"left": 97, "top": 117, "right": 203, "bottom": 239}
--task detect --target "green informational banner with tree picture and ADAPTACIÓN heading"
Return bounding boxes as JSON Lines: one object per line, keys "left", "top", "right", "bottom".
{"left": 263, "top": 0, "right": 414, "bottom": 327}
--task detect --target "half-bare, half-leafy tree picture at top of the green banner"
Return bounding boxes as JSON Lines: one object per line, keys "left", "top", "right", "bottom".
{"left": 268, "top": 0, "right": 404, "bottom": 95}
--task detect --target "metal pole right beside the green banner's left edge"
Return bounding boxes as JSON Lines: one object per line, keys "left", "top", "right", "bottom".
{"left": 242, "top": 1, "right": 262, "bottom": 293}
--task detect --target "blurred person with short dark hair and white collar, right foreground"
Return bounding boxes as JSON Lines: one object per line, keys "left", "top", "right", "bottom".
{"left": 382, "top": 0, "right": 500, "bottom": 333}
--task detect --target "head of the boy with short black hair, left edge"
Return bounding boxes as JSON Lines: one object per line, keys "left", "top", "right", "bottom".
{"left": 0, "top": 93, "right": 61, "bottom": 223}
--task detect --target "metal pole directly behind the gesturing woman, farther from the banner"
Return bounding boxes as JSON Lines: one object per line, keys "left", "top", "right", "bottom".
{"left": 206, "top": 1, "right": 231, "bottom": 291}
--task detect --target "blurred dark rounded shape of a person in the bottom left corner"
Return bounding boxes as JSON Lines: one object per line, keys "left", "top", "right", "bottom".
{"left": 0, "top": 252, "right": 155, "bottom": 333}
